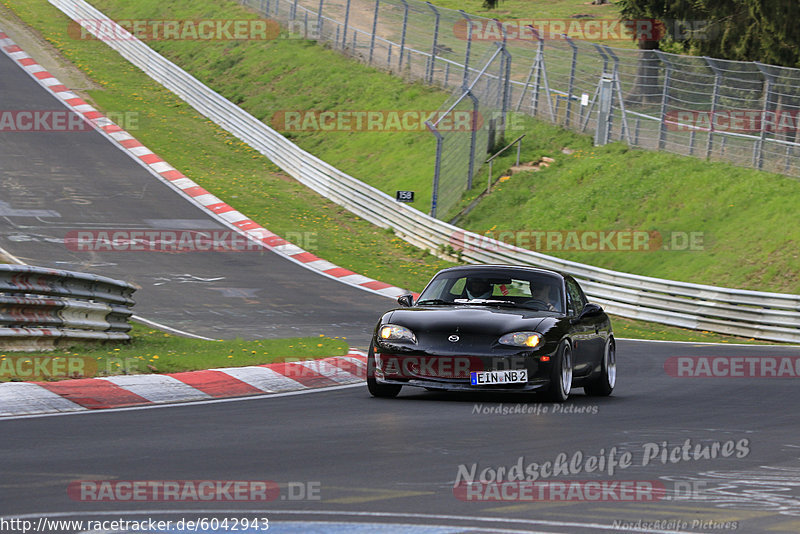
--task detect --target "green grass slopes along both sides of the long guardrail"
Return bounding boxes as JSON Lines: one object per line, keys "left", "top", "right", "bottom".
{"left": 5, "top": 0, "right": 800, "bottom": 348}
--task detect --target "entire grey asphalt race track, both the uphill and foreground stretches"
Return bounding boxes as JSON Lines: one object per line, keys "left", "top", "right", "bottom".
{"left": 0, "top": 16, "right": 800, "bottom": 533}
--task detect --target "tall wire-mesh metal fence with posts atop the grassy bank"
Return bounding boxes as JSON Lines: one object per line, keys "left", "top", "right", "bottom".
{"left": 242, "top": 0, "right": 800, "bottom": 217}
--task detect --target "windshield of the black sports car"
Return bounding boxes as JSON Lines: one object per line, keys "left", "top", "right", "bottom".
{"left": 417, "top": 270, "right": 564, "bottom": 313}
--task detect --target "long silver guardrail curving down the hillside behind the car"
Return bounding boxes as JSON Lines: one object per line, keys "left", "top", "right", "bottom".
{"left": 45, "top": 0, "right": 800, "bottom": 343}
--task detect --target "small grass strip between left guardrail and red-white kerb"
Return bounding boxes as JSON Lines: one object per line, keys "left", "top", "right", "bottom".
{"left": 0, "top": 324, "right": 348, "bottom": 382}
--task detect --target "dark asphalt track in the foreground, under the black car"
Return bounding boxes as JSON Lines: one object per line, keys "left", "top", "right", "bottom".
{"left": 0, "top": 341, "right": 800, "bottom": 532}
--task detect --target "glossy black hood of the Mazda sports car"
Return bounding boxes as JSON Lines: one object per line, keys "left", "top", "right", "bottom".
{"left": 387, "top": 306, "right": 553, "bottom": 336}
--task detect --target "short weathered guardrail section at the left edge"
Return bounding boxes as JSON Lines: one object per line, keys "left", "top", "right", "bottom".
{"left": 0, "top": 265, "right": 136, "bottom": 350}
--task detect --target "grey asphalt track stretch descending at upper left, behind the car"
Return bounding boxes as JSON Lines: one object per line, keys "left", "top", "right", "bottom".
{"left": 0, "top": 48, "right": 393, "bottom": 347}
